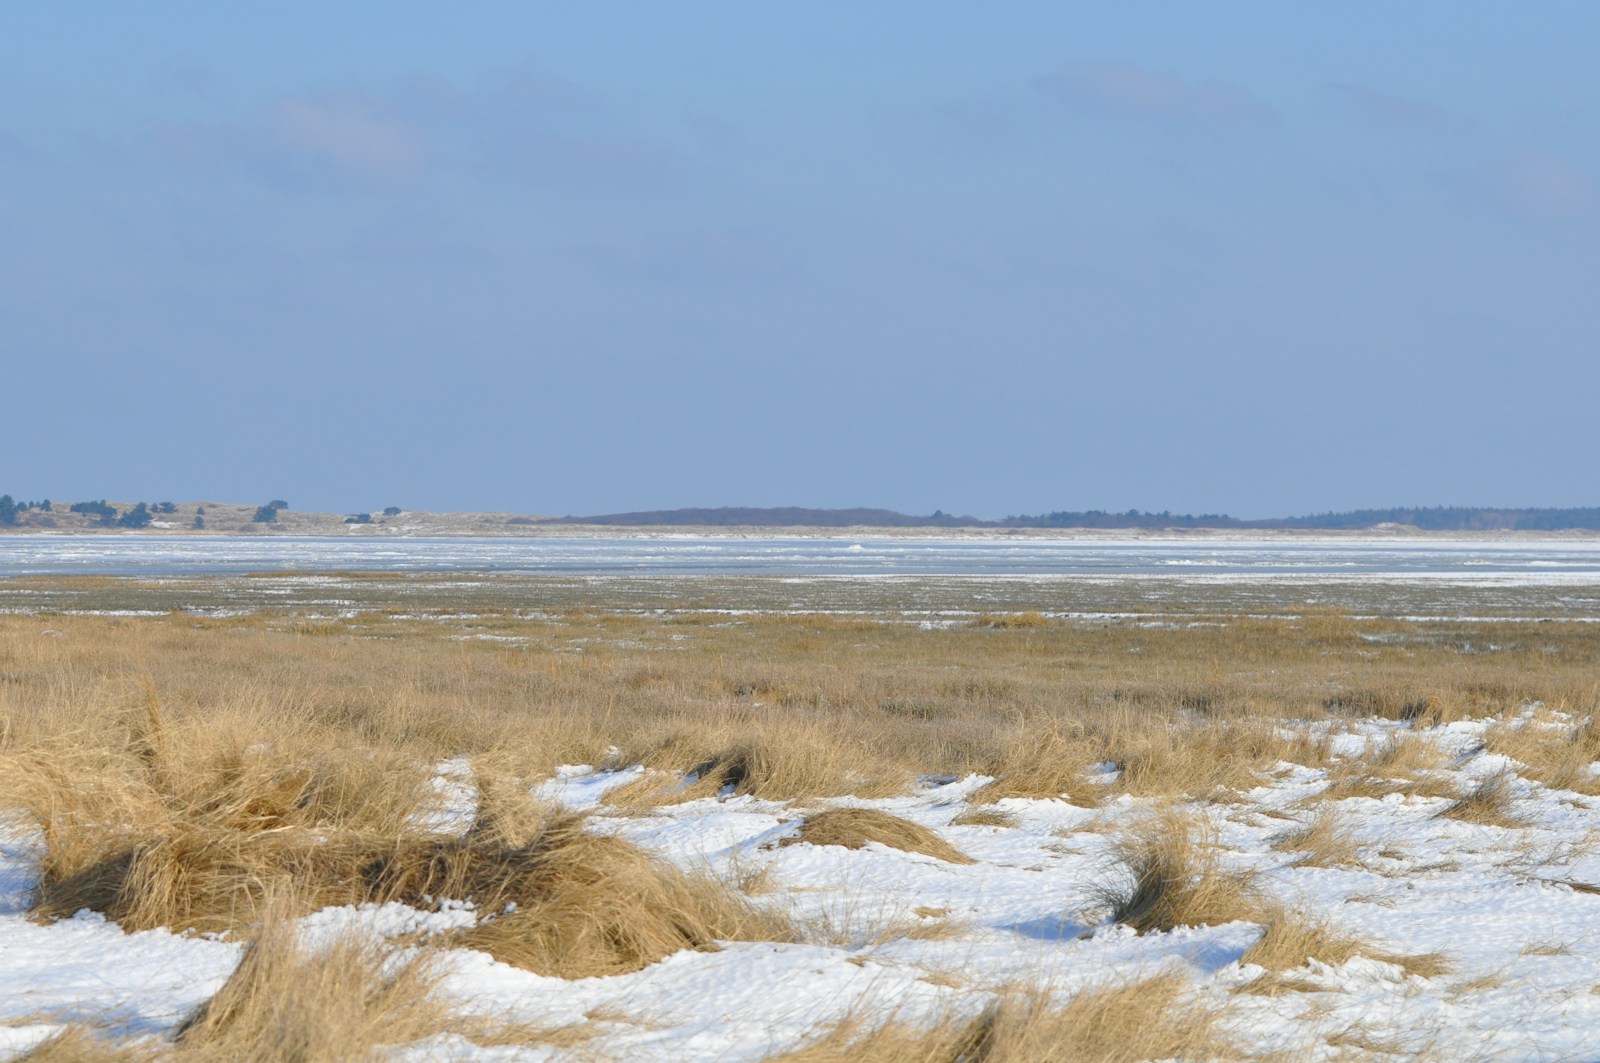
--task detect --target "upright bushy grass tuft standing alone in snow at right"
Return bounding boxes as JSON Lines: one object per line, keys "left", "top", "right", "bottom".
{"left": 1096, "top": 810, "right": 1269, "bottom": 933}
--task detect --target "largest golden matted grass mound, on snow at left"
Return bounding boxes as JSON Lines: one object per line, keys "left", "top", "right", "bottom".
{"left": 6, "top": 711, "right": 794, "bottom": 977}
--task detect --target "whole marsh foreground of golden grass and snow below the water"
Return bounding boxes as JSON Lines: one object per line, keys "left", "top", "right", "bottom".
{"left": 9, "top": 573, "right": 1600, "bottom": 1063}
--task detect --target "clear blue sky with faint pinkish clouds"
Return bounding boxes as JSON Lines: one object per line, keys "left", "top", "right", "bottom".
{"left": 0, "top": 3, "right": 1600, "bottom": 515}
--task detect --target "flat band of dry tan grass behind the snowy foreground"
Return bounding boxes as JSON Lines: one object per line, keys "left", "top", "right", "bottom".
{"left": 0, "top": 601, "right": 1597, "bottom": 800}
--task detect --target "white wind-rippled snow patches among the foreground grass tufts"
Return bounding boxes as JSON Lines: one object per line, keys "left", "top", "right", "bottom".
{"left": 9, "top": 710, "right": 1600, "bottom": 1060}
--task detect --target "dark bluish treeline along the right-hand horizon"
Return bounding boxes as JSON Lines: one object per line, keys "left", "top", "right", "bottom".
{"left": 556, "top": 506, "right": 1600, "bottom": 532}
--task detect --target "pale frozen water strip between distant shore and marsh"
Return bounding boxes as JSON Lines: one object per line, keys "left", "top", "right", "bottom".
{"left": 9, "top": 535, "right": 1600, "bottom": 584}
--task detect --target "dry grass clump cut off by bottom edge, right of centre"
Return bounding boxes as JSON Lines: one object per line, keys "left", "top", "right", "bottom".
{"left": 771, "top": 972, "right": 1238, "bottom": 1063}
